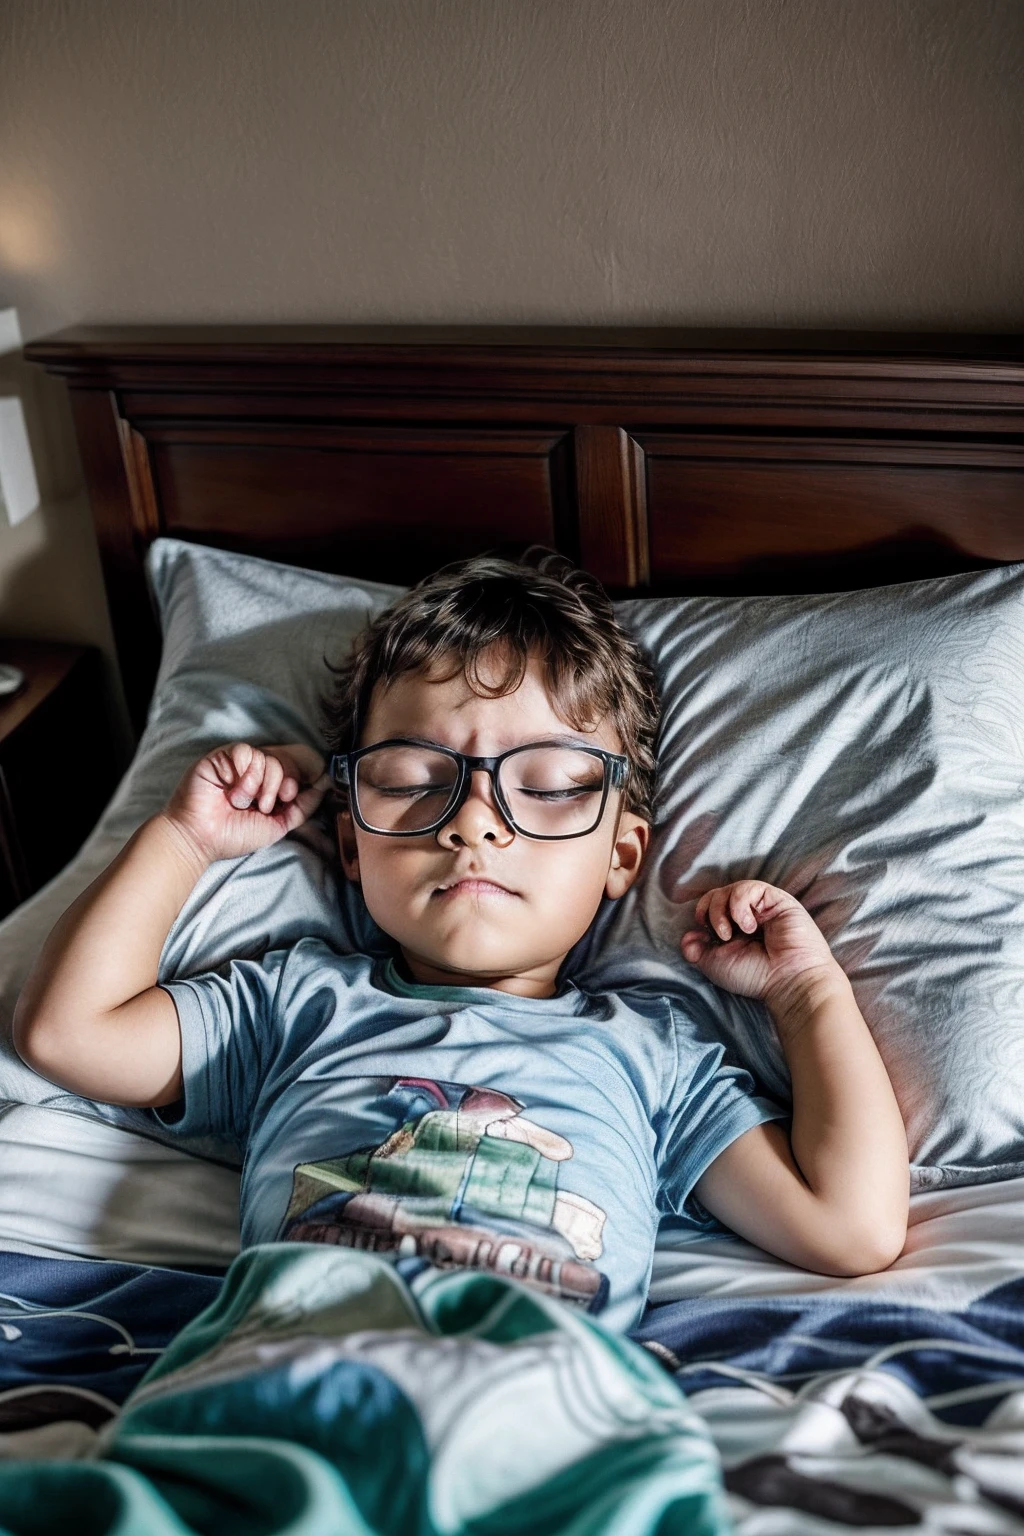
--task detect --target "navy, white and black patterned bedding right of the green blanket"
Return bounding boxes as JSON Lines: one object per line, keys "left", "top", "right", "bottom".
{"left": 639, "top": 1279, "right": 1024, "bottom": 1536}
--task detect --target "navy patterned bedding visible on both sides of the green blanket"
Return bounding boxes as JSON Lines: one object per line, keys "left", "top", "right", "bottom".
{"left": 0, "top": 1253, "right": 1024, "bottom": 1536}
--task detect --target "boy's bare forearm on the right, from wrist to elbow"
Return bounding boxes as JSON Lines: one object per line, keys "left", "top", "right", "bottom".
{"left": 769, "top": 965, "right": 909, "bottom": 1256}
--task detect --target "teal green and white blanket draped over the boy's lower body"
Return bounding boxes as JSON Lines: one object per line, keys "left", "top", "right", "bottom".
{"left": 0, "top": 1243, "right": 729, "bottom": 1536}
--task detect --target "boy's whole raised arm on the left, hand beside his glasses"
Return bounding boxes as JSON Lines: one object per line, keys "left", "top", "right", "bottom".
{"left": 14, "top": 742, "right": 327, "bottom": 1106}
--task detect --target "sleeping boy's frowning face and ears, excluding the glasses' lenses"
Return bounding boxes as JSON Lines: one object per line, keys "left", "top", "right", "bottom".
{"left": 338, "top": 657, "right": 649, "bottom": 997}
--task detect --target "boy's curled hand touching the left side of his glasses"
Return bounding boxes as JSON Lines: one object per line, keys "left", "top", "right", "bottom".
{"left": 164, "top": 742, "right": 329, "bottom": 863}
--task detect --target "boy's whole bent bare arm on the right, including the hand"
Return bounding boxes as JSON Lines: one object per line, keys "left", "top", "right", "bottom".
{"left": 682, "top": 880, "right": 909, "bottom": 1275}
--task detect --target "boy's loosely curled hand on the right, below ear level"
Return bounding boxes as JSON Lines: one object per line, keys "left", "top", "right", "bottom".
{"left": 682, "top": 880, "right": 843, "bottom": 1017}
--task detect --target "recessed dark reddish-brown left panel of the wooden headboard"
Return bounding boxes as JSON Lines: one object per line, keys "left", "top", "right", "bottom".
{"left": 149, "top": 424, "right": 570, "bottom": 582}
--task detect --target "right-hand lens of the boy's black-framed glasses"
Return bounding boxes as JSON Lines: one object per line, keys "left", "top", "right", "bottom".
{"left": 499, "top": 746, "right": 605, "bottom": 837}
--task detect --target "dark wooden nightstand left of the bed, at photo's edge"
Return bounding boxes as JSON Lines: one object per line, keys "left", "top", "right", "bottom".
{"left": 0, "top": 639, "right": 117, "bottom": 917}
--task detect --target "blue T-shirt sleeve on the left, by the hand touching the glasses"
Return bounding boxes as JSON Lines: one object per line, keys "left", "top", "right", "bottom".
{"left": 154, "top": 949, "right": 289, "bottom": 1147}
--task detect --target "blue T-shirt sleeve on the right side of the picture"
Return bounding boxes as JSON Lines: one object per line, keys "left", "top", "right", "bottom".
{"left": 659, "top": 1003, "right": 789, "bottom": 1229}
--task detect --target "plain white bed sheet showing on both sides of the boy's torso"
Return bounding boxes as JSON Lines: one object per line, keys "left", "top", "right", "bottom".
{"left": 0, "top": 1104, "right": 1024, "bottom": 1310}
